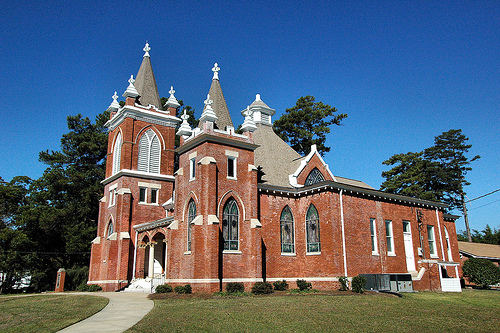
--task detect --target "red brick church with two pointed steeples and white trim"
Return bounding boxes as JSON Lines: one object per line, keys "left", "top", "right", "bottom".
{"left": 88, "top": 44, "right": 460, "bottom": 292}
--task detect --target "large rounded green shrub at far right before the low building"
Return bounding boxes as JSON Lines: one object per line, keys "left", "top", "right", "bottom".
{"left": 462, "top": 258, "right": 500, "bottom": 289}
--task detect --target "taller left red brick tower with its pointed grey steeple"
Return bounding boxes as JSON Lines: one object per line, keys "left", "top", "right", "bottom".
{"left": 88, "top": 44, "right": 181, "bottom": 291}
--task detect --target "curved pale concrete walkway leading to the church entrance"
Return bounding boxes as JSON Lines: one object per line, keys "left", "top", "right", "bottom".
{"left": 59, "top": 292, "right": 154, "bottom": 333}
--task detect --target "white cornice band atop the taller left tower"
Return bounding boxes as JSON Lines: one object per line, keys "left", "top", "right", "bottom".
{"left": 105, "top": 105, "right": 181, "bottom": 131}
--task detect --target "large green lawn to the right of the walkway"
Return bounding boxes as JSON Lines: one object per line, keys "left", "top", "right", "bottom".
{"left": 128, "top": 290, "right": 500, "bottom": 333}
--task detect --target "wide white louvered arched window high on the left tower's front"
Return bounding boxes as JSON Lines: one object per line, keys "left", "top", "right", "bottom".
{"left": 137, "top": 129, "right": 161, "bottom": 173}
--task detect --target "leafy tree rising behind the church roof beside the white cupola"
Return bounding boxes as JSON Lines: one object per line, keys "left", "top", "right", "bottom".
{"left": 273, "top": 96, "right": 347, "bottom": 156}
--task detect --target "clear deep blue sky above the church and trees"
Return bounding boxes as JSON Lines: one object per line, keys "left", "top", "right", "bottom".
{"left": 0, "top": 0, "right": 500, "bottom": 230}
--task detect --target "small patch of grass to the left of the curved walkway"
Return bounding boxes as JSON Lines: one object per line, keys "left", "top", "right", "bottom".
{"left": 0, "top": 295, "right": 108, "bottom": 332}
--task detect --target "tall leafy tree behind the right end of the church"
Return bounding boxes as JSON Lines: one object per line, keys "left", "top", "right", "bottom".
{"left": 381, "top": 129, "right": 480, "bottom": 210}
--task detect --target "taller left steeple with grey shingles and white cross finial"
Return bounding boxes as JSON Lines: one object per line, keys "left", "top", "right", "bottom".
{"left": 134, "top": 43, "right": 162, "bottom": 110}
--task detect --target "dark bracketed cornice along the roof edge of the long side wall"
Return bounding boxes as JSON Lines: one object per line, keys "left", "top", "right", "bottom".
{"left": 257, "top": 180, "right": 448, "bottom": 210}
